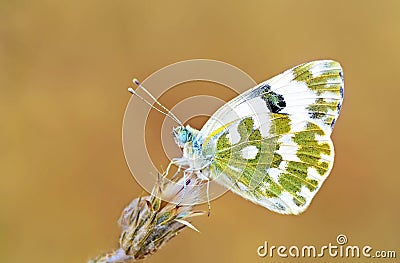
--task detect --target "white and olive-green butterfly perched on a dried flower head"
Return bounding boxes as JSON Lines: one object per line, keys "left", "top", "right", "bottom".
{"left": 130, "top": 60, "right": 344, "bottom": 214}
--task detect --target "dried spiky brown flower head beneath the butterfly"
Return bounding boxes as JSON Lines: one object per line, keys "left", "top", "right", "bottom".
{"left": 89, "top": 173, "right": 204, "bottom": 263}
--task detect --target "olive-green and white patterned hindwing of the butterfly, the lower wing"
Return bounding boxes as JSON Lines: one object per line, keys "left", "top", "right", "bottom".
{"left": 202, "top": 113, "right": 334, "bottom": 214}
